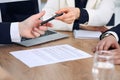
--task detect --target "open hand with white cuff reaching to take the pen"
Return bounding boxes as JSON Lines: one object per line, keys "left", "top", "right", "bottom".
{"left": 19, "top": 11, "right": 52, "bottom": 38}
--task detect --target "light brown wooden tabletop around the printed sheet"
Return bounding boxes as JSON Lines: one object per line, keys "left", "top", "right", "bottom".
{"left": 0, "top": 32, "right": 120, "bottom": 80}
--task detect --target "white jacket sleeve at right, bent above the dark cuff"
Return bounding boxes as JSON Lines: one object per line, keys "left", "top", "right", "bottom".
{"left": 86, "top": 0, "right": 115, "bottom": 26}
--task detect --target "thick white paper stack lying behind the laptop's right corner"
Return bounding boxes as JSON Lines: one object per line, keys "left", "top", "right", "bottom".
{"left": 73, "top": 30, "right": 101, "bottom": 39}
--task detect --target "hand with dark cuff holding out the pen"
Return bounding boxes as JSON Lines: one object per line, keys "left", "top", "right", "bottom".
{"left": 56, "top": 7, "right": 80, "bottom": 24}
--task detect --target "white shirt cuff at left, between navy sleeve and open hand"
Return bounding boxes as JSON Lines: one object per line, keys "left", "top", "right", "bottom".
{"left": 10, "top": 22, "right": 21, "bottom": 42}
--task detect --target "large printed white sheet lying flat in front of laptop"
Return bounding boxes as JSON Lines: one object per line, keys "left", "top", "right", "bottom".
{"left": 10, "top": 44, "right": 92, "bottom": 67}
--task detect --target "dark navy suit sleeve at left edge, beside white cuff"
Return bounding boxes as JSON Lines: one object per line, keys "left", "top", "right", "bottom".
{"left": 0, "top": 23, "right": 12, "bottom": 44}
